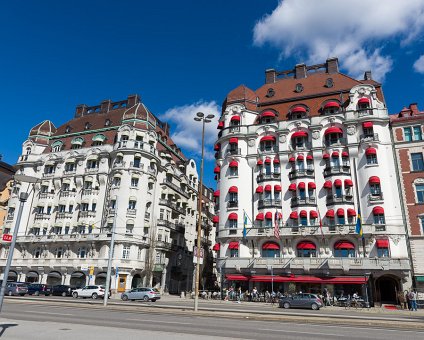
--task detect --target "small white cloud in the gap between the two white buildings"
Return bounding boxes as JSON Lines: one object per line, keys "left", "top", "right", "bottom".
{"left": 159, "top": 101, "right": 221, "bottom": 159}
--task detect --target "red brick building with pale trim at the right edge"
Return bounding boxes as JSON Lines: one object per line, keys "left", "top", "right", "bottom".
{"left": 390, "top": 104, "right": 424, "bottom": 292}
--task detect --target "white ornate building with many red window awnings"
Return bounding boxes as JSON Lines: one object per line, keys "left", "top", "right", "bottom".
{"left": 214, "top": 58, "right": 411, "bottom": 303}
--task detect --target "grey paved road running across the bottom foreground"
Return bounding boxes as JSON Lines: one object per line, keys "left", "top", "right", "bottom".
{"left": 0, "top": 300, "right": 424, "bottom": 340}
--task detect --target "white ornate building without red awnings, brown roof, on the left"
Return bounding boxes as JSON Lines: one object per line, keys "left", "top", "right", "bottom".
{"left": 0, "top": 95, "right": 214, "bottom": 293}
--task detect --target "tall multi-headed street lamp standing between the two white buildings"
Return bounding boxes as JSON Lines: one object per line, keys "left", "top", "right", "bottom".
{"left": 194, "top": 112, "right": 215, "bottom": 312}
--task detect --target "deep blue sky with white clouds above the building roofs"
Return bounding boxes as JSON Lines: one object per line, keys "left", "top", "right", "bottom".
{"left": 0, "top": 0, "right": 424, "bottom": 186}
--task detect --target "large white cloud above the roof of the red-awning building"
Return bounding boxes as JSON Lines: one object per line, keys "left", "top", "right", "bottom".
{"left": 254, "top": 0, "right": 424, "bottom": 81}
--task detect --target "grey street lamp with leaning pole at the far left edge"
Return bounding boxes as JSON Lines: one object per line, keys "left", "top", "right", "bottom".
{"left": 0, "top": 175, "right": 39, "bottom": 312}
